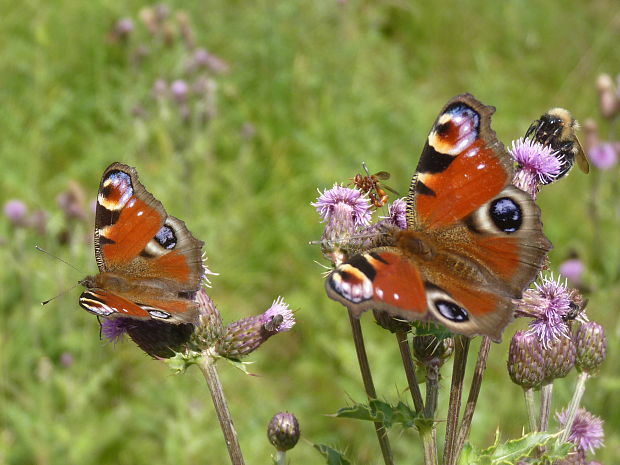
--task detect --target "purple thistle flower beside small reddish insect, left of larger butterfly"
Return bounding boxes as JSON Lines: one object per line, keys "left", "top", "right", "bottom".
{"left": 310, "top": 184, "right": 372, "bottom": 228}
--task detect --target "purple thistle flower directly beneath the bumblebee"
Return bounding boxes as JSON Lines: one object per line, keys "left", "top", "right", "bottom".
{"left": 508, "top": 138, "right": 564, "bottom": 198}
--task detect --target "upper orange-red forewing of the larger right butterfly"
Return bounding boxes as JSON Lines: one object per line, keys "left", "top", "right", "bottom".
{"left": 409, "top": 94, "right": 514, "bottom": 229}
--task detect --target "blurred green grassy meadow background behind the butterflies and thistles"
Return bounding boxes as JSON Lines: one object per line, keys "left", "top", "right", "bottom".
{"left": 0, "top": 0, "right": 620, "bottom": 465}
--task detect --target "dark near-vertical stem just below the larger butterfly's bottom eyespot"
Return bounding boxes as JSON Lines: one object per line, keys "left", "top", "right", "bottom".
{"left": 443, "top": 336, "right": 470, "bottom": 465}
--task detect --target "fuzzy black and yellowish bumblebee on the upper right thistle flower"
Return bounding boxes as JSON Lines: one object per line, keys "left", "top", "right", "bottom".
{"left": 525, "top": 108, "right": 590, "bottom": 184}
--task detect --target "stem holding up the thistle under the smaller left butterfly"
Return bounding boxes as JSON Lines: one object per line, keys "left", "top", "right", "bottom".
{"left": 199, "top": 353, "right": 245, "bottom": 465}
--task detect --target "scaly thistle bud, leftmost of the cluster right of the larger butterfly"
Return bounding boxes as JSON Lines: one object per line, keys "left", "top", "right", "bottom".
{"left": 508, "top": 331, "right": 544, "bottom": 389}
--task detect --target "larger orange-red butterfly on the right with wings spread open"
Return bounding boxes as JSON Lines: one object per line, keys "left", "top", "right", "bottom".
{"left": 326, "top": 94, "right": 551, "bottom": 341}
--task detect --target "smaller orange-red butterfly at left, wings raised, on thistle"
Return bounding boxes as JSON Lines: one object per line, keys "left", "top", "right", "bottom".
{"left": 79, "top": 163, "right": 205, "bottom": 324}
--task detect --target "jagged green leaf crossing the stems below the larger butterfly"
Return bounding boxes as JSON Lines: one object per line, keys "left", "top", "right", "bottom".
{"left": 335, "top": 399, "right": 430, "bottom": 428}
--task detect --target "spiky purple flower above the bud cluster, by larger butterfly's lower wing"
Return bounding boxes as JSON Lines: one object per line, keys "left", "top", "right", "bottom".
{"left": 516, "top": 275, "right": 572, "bottom": 347}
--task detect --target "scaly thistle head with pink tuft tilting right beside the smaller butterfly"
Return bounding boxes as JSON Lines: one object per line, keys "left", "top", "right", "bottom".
{"left": 216, "top": 297, "right": 295, "bottom": 359}
